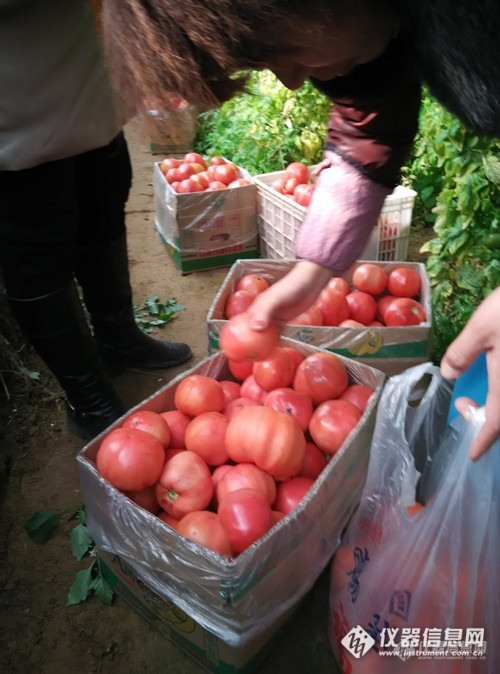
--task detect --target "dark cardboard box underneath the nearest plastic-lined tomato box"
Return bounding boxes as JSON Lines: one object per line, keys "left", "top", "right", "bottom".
{"left": 99, "top": 552, "right": 301, "bottom": 674}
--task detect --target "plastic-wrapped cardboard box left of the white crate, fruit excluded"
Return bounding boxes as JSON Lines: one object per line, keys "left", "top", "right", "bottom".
{"left": 153, "top": 162, "right": 258, "bottom": 274}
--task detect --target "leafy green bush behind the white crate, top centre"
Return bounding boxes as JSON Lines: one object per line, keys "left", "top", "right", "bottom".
{"left": 195, "top": 71, "right": 331, "bottom": 175}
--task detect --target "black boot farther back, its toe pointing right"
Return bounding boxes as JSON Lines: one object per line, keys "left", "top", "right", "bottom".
{"left": 75, "top": 236, "right": 193, "bottom": 372}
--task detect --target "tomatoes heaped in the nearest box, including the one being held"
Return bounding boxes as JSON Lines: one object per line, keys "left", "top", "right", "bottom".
{"left": 96, "top": 334, "right": 373, "bottom": 557}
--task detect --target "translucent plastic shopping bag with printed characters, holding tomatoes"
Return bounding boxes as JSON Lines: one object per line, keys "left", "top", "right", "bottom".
{"left": 329, "top": 364, "right": 500, "bottom": 674}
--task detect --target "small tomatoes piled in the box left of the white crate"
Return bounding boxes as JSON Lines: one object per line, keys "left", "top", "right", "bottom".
{"left": 159, "top": 152, "right": 252, "bottom": 194}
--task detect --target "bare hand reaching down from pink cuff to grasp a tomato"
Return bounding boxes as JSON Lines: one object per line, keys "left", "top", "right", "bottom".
{"left": 248, "top": 260, "right": 332, "bottom": 330}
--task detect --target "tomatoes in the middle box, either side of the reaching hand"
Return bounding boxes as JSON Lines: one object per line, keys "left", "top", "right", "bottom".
{"left": 225, "top": 262, "right": 426, "bottom": 328}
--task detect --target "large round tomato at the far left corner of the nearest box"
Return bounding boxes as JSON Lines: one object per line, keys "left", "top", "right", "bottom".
{"left": 96, "top": 428, "right": 165, "bottom": 491}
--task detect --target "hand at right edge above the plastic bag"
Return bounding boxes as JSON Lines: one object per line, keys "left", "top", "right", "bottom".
{"left": 441, "top": 288, "right": 500, "bottom": 460}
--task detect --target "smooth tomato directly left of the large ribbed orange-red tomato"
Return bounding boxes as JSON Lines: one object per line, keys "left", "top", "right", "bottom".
{"left": 186, "top": 412, "right": 229, "bottom": 466}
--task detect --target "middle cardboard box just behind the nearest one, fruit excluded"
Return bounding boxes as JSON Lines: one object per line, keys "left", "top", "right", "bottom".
{"left": 207, "top": 260, "right": 432, "bottom": 376}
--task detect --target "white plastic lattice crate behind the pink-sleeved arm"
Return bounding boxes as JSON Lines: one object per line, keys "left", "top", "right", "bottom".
{"left": 254, "top": 167, "right": 417, "bottom": 262}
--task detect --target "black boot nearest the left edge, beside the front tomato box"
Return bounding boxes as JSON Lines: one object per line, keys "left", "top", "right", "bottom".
{"left": 8, "top": 281, "right": 125, "bottom": 440}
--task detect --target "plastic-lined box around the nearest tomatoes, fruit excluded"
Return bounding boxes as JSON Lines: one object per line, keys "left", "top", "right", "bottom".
{"left": 77, "top": 339, "right": 385, "bottom": 672}
